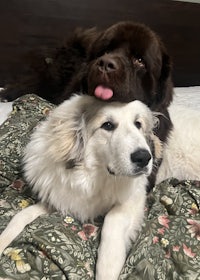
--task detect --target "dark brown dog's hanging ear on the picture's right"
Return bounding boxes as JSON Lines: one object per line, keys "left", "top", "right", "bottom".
{"left": 152, "top": 45, "right": 173, "bottom": 112}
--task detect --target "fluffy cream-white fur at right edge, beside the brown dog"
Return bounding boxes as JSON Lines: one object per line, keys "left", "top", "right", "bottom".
{"left": 157, "top": 104, "right": 200, "bottom": 183}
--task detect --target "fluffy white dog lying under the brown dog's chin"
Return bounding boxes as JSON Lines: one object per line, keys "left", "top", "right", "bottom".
{"left": 0, "top": 96, "right": 161, "bottom": 280}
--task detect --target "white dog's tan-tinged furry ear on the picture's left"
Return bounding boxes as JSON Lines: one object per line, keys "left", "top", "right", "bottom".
{"left": 48, "top": 96, "right": 93, "bottom": 168}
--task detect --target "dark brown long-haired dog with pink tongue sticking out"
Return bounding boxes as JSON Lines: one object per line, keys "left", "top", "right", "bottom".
{"left": 0, "top": 22, "right": 173, "bottom": 190}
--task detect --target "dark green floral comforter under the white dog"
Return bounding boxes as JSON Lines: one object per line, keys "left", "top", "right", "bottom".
{"left": 0, "top": 95, "right": 200, "bottom": 280}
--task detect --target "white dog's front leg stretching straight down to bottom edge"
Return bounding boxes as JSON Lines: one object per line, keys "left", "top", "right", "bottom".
{"left": 96, "top": 199, "right": 144, "bottom": 280}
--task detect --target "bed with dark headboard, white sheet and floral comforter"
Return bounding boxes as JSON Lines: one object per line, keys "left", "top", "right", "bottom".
{"left": 0, "top": 0, "right": 200, "bottom": 280}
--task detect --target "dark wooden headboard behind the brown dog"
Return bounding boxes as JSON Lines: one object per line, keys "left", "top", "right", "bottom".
{"left": 0, "top": 0, "right": 200, "bottom": 86}
